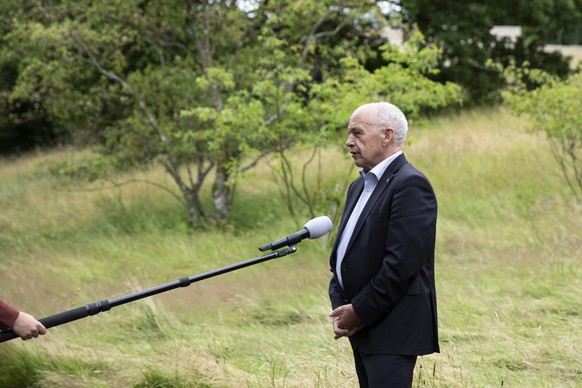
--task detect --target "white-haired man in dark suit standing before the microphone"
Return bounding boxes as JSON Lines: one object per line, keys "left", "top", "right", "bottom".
{"left": 329, "top": 102, "right": 439, "bottom": 387}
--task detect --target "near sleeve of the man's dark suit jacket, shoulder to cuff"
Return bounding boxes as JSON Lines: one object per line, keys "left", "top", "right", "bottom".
{"left": 352, "top": 174, "right": 437, "bottom": 326}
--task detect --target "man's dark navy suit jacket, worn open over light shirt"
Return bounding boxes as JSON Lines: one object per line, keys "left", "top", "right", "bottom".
{"left": 329, "top": 155, "right": 439, "bottom": 355}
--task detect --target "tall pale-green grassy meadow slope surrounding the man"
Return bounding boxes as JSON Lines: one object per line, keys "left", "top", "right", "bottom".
{"left": 0, "top": 110, "right": 582, "bottom": 387}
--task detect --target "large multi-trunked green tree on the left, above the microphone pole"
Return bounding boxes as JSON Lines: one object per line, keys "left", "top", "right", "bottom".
{"left": 8, "top": 1, "right": 282, "bottom": 225}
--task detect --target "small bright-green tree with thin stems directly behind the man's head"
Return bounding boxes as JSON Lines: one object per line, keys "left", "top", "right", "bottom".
{"left": 277, "top": 31, "right": 461, "bottom": 216}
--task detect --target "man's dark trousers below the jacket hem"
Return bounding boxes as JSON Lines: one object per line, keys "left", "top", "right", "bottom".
{"left": 353, "top": 349, "right": 416, "bottom": 388}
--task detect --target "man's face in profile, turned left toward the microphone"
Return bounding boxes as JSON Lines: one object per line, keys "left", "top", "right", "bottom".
{"left": 346, "top": 109, "right": 389, "bottom": 171}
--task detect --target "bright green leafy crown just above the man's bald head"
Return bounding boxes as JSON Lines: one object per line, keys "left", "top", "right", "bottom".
{"left": 310, "top": 33, "right": 461, "bottom": 128}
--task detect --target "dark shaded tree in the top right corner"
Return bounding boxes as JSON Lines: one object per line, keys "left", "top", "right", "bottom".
{"left": 398, "top": 0, "right": 582, "bottom": 103}
